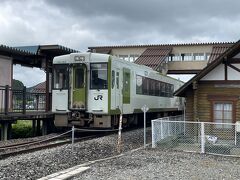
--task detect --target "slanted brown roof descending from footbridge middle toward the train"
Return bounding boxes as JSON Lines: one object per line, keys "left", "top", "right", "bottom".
{"left": 134, "top": 47, "right": 172, "bottom": 70}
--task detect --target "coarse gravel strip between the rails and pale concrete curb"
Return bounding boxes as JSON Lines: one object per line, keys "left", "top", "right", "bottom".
{"left": 0, "top": 130, "right": 149, "bottom": 180}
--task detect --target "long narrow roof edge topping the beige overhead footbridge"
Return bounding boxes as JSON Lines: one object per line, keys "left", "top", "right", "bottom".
{"left": 88, "top": 42, "right": 235, "bottom": 49}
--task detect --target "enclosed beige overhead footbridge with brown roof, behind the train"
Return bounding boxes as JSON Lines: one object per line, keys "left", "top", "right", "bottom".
{"left": 88, "top": 42, "right": 234, "bottom": 74}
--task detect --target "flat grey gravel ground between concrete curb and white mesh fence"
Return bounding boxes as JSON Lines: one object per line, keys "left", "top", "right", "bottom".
{"left": 73, "top": 149, "right": 240, "bottom": 180}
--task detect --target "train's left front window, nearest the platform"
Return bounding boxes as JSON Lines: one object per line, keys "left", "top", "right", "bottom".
{"left": 53, "top": 65, "right": 68, "bottom": 89}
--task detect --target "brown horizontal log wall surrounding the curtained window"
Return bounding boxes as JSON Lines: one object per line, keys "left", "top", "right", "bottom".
{"left": 186, "top": 81, "right": 240, "bottom": 123}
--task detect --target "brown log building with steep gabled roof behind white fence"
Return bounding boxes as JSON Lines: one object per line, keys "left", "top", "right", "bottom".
{"left": 175, "top": 41, "right": 240, "bottom": 126}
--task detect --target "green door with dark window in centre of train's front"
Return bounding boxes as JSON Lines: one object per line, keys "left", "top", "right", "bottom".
{"left": 71, "top": 64, "right": 87, "bottom": 109}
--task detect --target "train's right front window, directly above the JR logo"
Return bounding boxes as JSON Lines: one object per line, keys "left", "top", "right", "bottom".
{"left": 90, "top": 63, "right": 108, "bottom": 89}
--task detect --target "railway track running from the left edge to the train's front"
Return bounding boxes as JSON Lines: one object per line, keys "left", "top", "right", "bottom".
{"left": 0, "top": 135, "right": 99, "bottom": 159}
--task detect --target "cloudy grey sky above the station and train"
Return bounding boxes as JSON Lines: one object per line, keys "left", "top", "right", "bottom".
{"left": 0, "top": 0, "right": 240, "bottom": 86}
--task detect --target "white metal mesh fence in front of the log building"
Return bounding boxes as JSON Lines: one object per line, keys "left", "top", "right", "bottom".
{"left": 152, "top": 116, "right": 240, "bottom": 156}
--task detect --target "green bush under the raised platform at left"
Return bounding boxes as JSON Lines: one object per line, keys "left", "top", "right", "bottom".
{"left": 12, "top": 120, "right": 33, "bottom": 139}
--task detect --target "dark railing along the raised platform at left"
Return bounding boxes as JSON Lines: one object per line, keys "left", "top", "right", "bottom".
{"left": 0, "top": 85, "right": 46, "bottom": 115}
